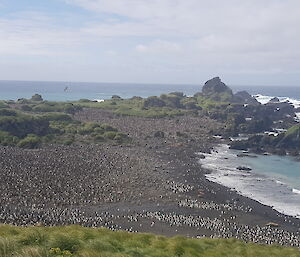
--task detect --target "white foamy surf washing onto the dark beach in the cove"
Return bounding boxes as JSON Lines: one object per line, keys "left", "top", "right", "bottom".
{"left": 200, "top": 145, "right": 300, "bottom": 218}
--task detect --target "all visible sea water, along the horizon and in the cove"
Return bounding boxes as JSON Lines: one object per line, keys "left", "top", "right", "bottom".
{"left": 0, "top": 81, "right": 300, "bottom": 218}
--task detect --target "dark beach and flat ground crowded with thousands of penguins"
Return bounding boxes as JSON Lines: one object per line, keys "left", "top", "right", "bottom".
{"left": 0, "top": 109, "right": 300, "bottom": 246}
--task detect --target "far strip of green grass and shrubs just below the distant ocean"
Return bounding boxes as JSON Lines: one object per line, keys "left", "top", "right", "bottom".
{"left": 7, "top": 92, "right": 228, "bottom": 118}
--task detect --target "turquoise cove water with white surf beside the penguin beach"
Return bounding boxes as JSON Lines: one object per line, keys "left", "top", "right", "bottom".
{"left": 200, "top": 145, "right": 300, "bottom": 218}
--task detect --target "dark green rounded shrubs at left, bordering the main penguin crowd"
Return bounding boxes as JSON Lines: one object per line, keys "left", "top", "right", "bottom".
{"left": 0, "top": 109, "right": 130, "bottom": 148}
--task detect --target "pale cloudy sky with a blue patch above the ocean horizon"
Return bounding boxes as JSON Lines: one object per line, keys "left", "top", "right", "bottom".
{"left": 0, "top": 0, "right": 300, "bottom": 86}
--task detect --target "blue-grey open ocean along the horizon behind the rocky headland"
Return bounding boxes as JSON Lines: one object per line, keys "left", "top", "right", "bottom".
{"left": 0, "top": 80, "right": 300, "bottom": 101}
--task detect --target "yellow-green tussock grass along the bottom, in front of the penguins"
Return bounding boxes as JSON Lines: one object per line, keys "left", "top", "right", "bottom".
{"left": 0, "top": 225, "right": 300, "bottom": 257}
